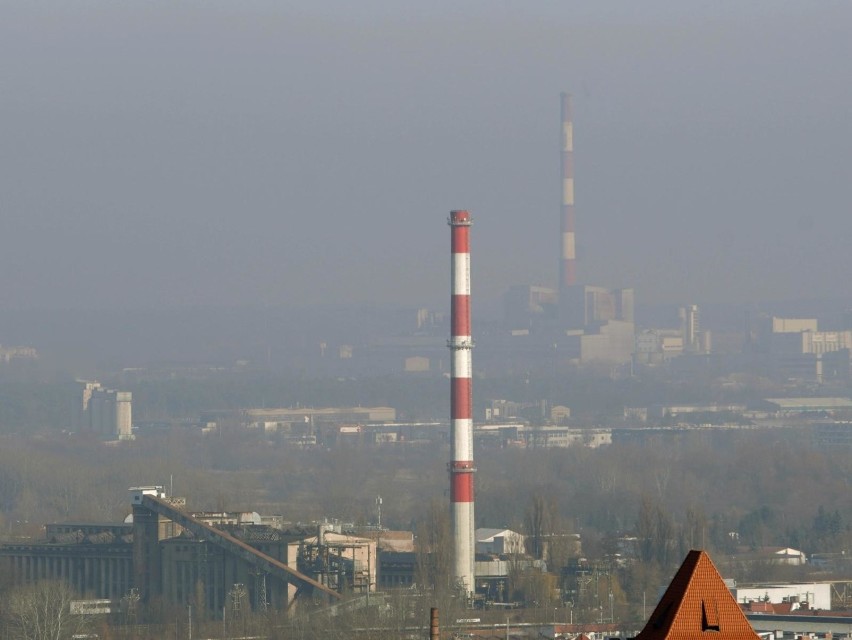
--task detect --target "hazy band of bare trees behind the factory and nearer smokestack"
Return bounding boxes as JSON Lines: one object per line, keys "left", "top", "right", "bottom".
{"left": 5, "top": 429, "right": 852, "bottom": 617}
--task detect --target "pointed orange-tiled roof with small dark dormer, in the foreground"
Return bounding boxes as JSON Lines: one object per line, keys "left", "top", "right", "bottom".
{"left": 636, "top": 550, "right": 759, "bottom": 640}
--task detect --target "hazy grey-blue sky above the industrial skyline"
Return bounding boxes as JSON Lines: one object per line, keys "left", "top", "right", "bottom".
{"left": 0, "top": 0, "right": 852, "bottom": 309}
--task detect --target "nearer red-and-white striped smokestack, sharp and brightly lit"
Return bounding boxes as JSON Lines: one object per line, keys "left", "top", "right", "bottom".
{"left": 447, "top": 211, "right": 476, "bottom": 595}
